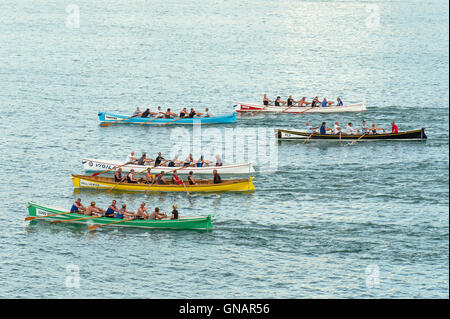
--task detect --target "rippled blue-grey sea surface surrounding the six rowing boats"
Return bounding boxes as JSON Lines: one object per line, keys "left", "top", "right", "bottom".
{"left": 0, "top": 0, "right": 449, "bottom": 298}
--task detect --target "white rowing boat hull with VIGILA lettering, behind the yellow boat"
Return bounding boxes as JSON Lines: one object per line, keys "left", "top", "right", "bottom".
{"left": 82, "top": 158, "right": 255, "bottom": 175}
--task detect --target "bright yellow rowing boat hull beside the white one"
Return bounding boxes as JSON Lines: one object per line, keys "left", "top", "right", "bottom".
{"left": 72, "top": 175, "right": 255, "bottom": 192}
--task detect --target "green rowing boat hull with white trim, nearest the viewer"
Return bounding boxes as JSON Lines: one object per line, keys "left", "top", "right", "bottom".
{"left": 27, "top": 202, "right": 213, "bottom": 230}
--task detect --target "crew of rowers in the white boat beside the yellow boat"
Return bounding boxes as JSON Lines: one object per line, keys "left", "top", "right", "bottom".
{"left": 125, "top": 151, "right": 223, "bottom": 167}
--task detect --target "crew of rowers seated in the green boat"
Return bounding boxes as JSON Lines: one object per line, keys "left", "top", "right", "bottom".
{"left": 70, "top": 198, "right": 179, "bottom": 220}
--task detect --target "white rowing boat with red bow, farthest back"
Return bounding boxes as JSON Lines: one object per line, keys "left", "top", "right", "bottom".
{"left": 236, "top": 103, "right": 367, "bottom": 114}
